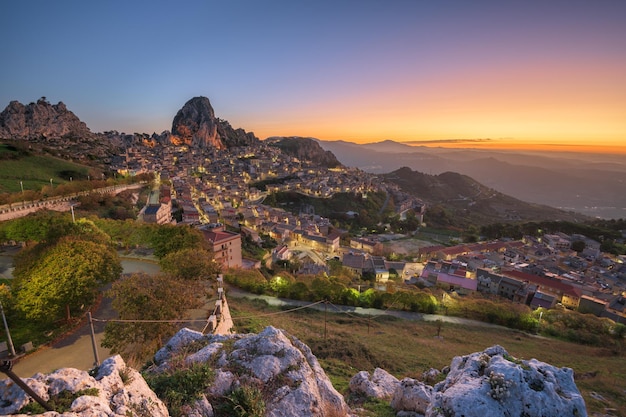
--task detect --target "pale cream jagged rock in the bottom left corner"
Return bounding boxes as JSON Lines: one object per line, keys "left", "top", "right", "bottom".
{"left": 0, "top": 356, "right": 169, "bottom": 417}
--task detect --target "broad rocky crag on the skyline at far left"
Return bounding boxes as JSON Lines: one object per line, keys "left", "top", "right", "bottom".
{"left": 0, "top": 97, "right": 93, "bottom": 139}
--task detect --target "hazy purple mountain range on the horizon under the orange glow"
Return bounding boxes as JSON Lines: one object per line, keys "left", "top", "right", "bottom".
{"left": 318, "top": 140, "right": 626, "bottom": 218}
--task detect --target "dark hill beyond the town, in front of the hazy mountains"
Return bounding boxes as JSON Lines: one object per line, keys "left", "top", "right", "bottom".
{"left": 381, "top": 167, "right": 590, "bottom": 228}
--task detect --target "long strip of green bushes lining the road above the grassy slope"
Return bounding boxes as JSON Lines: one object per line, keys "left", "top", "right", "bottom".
{"left": 224, "top": 271, "right": 626, "bottom": 352}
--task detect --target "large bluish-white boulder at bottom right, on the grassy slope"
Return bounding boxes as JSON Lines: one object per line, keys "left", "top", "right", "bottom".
{"left": 350, "top": 345, "right": 587, "bottom": 417}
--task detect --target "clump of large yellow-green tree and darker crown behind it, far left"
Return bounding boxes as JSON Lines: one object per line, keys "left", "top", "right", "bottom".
{"left": 5, "top": 213, "right": 122, "bottom": 324}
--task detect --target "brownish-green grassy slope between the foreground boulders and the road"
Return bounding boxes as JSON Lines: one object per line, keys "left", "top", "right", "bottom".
{"left": 229, "top": 299, "right": 626, "bottom": 417}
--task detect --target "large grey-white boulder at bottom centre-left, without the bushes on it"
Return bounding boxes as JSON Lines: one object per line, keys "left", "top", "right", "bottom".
{"left": 149, "top": 326, "right": 350, "bottom": 417}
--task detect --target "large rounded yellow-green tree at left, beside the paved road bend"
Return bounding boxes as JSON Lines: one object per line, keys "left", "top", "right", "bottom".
{"left": 15, "top": 236, "right": 122, "bottom": 322}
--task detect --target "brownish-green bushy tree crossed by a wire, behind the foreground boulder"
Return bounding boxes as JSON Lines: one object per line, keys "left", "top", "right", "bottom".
{"left": 102, "top": 273, "right": 204, "bottom": 363}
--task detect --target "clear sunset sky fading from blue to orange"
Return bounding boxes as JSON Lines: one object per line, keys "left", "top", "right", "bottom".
{"left": 0, "top": 0, "right": 626, "bottom": 152}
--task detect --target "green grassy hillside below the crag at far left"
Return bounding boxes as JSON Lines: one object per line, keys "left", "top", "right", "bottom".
{"left": 0, "top": 144, "right": 88, "bottom": 193}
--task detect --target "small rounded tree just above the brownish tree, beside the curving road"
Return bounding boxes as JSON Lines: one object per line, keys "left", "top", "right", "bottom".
{"left": 159, "top": 248, "right": 221, "bottom": 280}
